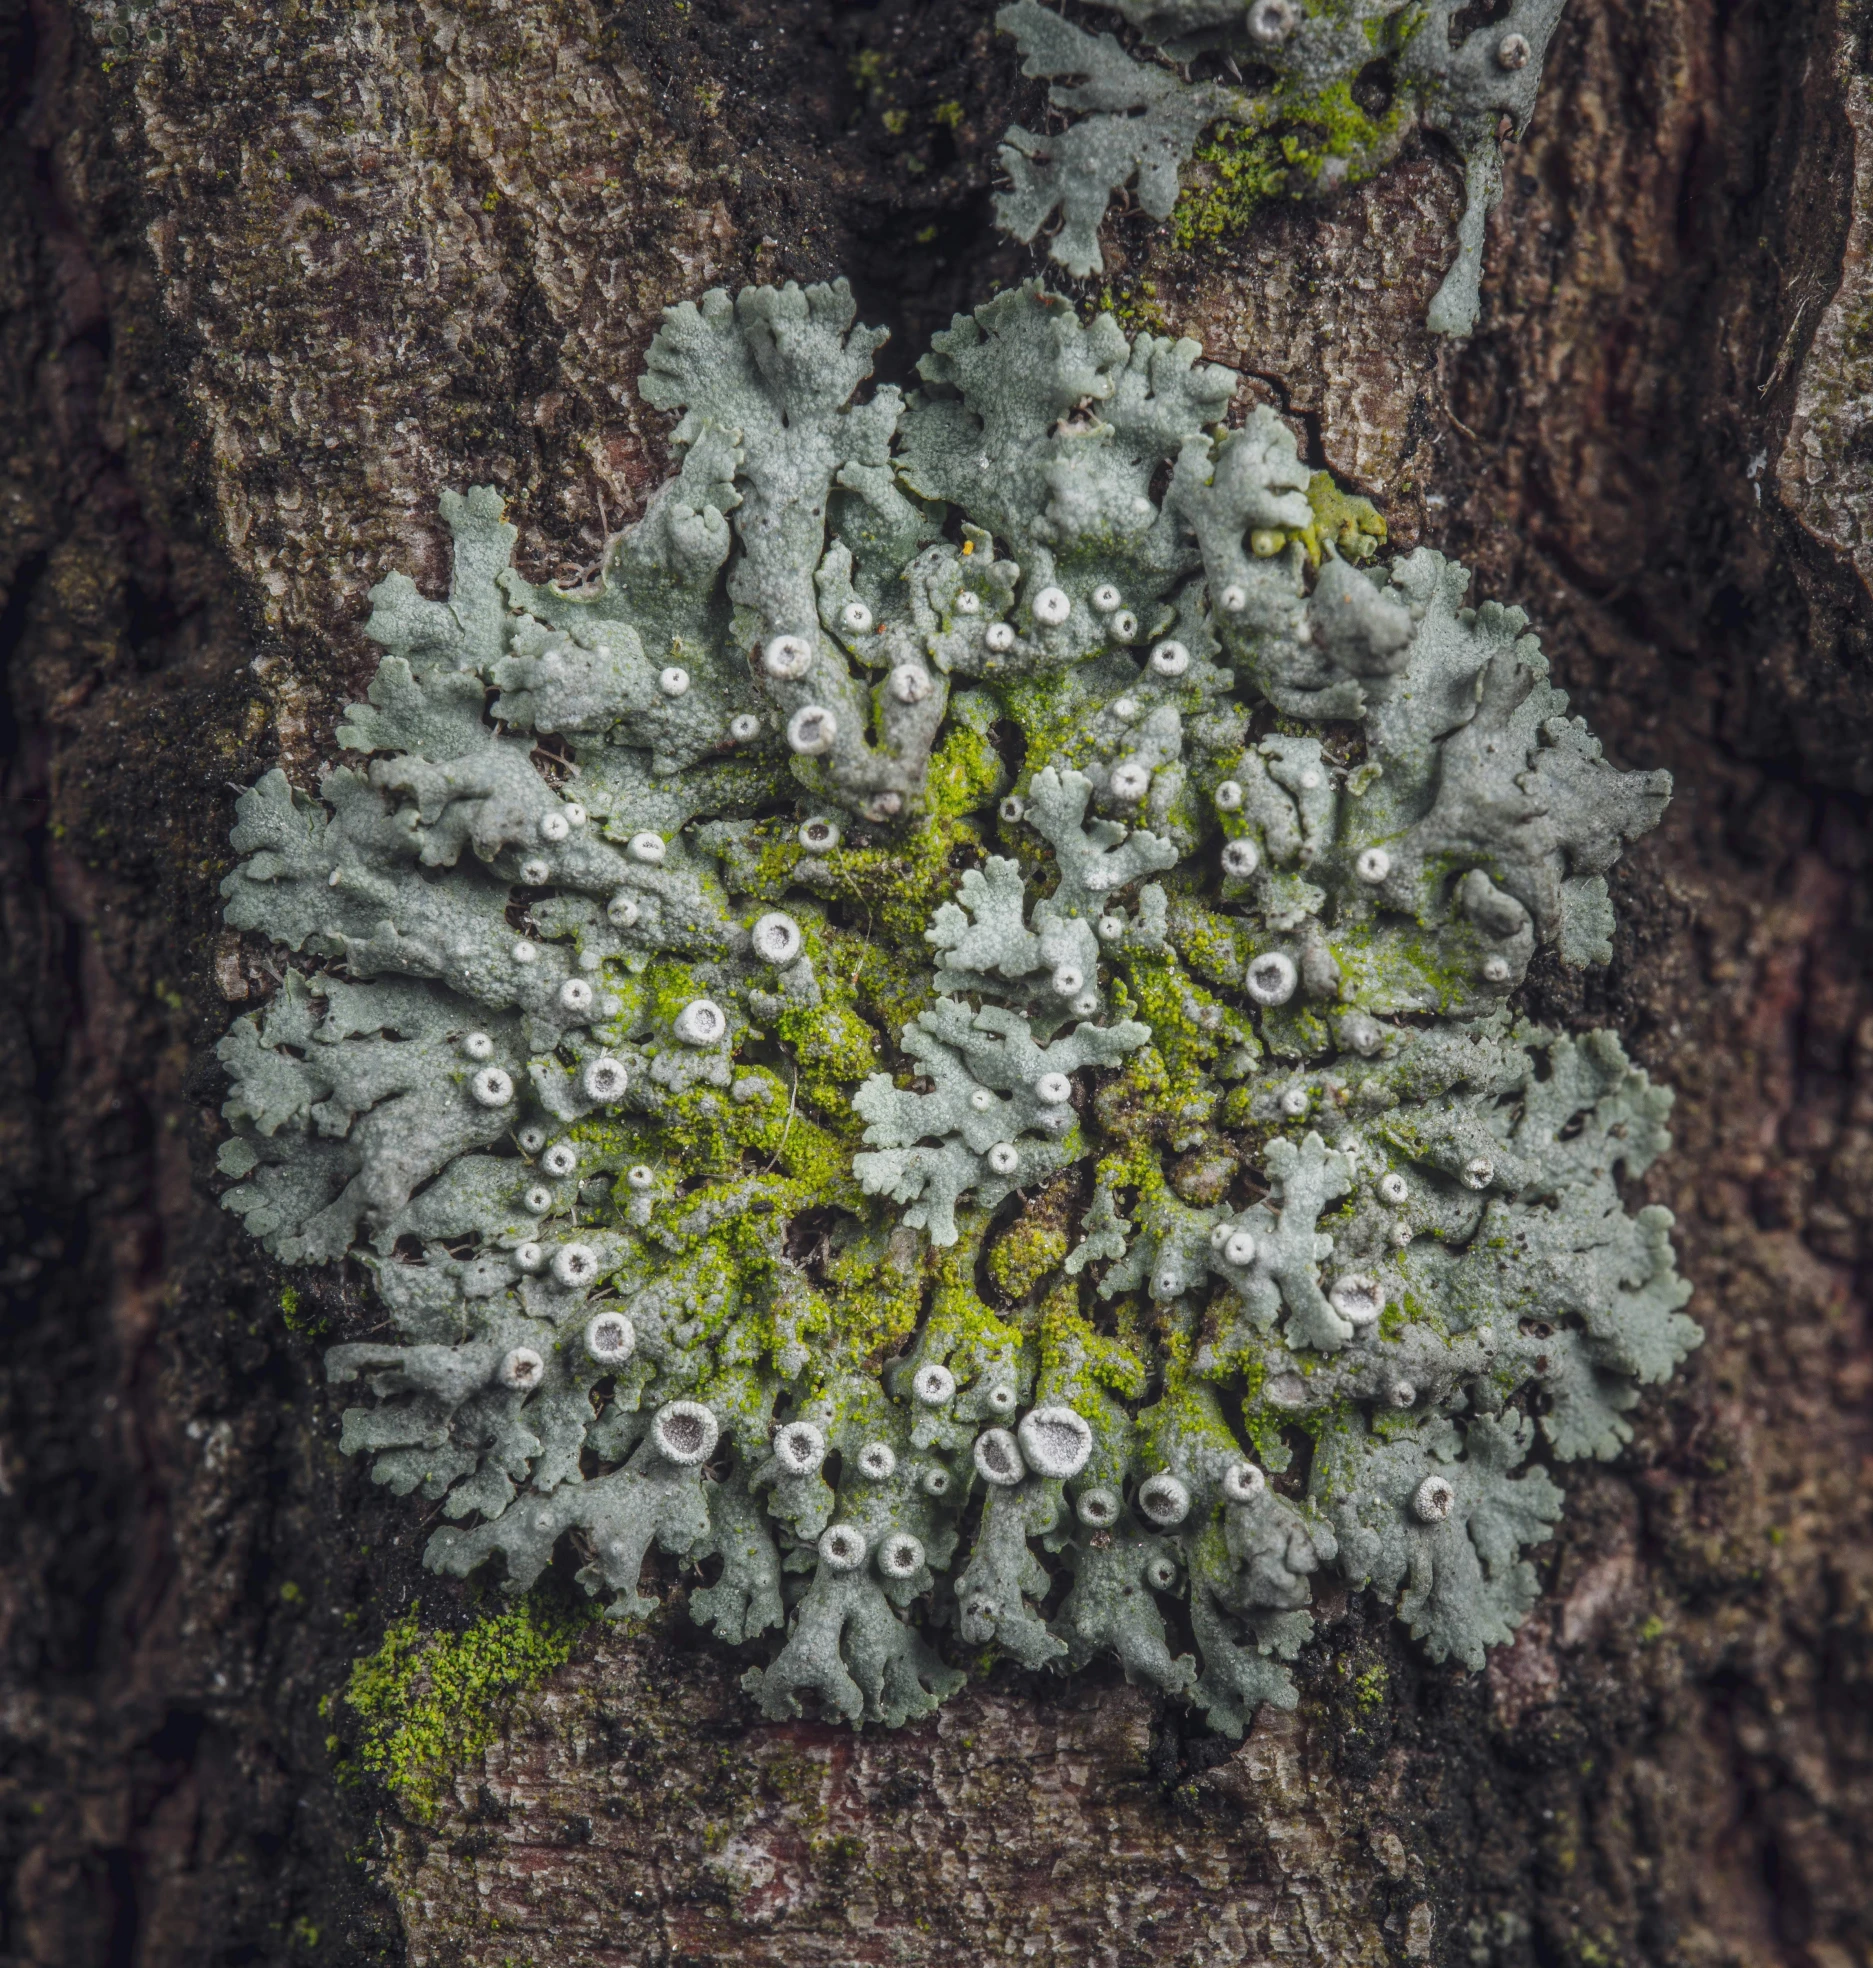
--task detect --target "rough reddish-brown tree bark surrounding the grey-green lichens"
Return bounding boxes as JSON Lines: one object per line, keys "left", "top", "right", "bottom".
{"left": 0, "top": 0, "right": 1873, "bottom": 1968}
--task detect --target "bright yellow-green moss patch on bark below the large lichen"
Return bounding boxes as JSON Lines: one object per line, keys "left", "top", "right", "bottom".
{"left": 342, "top": 1592, "right": 596, "bottom": 1824}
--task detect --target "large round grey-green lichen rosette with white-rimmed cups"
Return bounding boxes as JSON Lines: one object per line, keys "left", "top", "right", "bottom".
{"left": 220, "top": 287, "right": 1698, "bottom": 1732}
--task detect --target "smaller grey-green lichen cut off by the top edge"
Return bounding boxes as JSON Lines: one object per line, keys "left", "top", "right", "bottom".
{"left": 996, "top": 0, "right": 1566, "bottom": 335}
